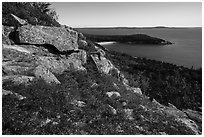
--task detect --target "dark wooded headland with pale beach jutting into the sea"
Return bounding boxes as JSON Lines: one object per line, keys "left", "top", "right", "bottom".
{"left": 84, "top": 34, "right": 173, "bottom": 45}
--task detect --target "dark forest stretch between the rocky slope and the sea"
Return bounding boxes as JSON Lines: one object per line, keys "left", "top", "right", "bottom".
{"left": 108, "top": 51, "right": 202, "bottom": 111}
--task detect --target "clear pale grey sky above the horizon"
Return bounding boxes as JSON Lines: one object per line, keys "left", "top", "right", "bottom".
{"left": 51, "top": 2, "right": 202, "bottom": 27}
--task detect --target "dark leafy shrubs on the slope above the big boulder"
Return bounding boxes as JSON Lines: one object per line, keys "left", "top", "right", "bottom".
{"left": 2, "top": 2, "right": 60, "bottom": 26}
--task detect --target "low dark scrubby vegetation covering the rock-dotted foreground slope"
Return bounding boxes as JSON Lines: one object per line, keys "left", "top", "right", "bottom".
{"left": 2, "top": 58, "right": 199, "bottom": 135}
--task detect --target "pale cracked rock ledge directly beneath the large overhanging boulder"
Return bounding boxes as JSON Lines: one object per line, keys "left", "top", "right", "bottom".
{"left": 2, "top": 42, "right": 86, "bottom": 83}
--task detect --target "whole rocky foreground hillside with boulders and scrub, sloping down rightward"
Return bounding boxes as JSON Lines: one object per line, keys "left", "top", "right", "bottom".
{"left": 2, "top": 14, "right": 202, "bottom": 135}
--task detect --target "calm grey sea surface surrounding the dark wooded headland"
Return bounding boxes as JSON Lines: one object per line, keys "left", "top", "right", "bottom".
{"left": 77, "top": 28, "right": 202, "bottom": 68}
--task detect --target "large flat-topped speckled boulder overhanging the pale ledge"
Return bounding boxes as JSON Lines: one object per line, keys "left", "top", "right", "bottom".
{"left": 16, "top": 25, "right": 78, "bottom": 51}
